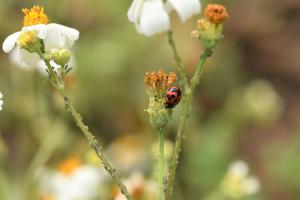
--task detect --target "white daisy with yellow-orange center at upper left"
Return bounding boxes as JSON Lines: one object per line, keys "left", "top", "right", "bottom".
{"left": 2, "top": 6, "right": 79, "bottom": 75}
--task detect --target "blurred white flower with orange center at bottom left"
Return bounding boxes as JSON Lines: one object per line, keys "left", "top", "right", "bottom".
{"left": 38, "top": 158, "right": 107, "bottom": 200}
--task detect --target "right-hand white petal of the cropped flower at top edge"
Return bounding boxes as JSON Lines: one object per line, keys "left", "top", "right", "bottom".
{"left": 167, "top": 0, "right": 201, "bottom": 22}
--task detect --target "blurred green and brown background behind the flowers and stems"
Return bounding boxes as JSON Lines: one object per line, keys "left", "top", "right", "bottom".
{"left": 0, "top": 0, "right": 300, "bottom": 200}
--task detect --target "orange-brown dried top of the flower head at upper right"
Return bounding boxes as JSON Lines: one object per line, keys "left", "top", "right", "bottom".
{"left": 204, "top": 4, "right": 229, "bottom": 24}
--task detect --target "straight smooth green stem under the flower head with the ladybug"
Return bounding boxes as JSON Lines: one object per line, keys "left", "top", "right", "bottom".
{"left": 157, "top": 128, "right": 165, "bottom": 200}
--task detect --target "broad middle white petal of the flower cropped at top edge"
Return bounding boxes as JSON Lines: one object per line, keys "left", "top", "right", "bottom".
{"left": 139, "top": 0, "right": 170, "bottom": 36}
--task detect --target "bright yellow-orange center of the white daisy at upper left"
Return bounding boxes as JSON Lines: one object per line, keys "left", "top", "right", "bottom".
{"left": 22, "top": 6, "right": 48, "bottom": 27}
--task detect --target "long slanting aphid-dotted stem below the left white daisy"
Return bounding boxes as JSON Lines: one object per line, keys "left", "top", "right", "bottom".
{"left": 41, "top": 55, "right": 132, "bottom": 200}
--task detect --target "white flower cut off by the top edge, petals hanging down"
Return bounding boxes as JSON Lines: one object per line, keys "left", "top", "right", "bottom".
{"left": 128, "top": 0, "right": 201, "bottom": 36}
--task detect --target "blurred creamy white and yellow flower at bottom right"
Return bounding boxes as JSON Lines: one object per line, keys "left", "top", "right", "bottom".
{"left": 221, "top": 161, "right": 260, "bottom": 199}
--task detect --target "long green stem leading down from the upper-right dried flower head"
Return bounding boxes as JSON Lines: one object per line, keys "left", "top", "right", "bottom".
{"left": 165, "top": 49, "right": 212, "bottom": 200}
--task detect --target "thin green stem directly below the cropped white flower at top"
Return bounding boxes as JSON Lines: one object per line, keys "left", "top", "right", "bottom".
{"left": 167, "top": 31, "right": 188, "bottom": 89}
